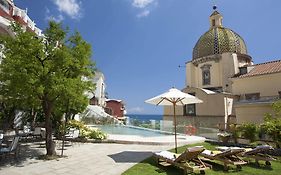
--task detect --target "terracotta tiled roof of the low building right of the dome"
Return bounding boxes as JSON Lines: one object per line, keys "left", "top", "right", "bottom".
{"left": 236, "top": 60, "right": 281, "bottom": 78}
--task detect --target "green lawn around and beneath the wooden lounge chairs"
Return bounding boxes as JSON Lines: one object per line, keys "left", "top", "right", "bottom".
{"left": 122, "top": 143, "right": 281, "bottom": 175}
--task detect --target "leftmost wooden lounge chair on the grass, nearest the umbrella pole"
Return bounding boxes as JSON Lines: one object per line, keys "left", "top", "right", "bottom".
{"left": 153, "top": 147, "right": 210, "bottom": 174}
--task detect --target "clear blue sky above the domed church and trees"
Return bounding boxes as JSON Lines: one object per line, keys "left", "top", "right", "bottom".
{"left": 14, "top": 0, "right": 281, "bottom": 114}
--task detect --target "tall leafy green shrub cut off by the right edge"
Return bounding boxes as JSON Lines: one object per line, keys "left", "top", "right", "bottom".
{"left": 261, "top": 100, "right": 281, "bottom": 148}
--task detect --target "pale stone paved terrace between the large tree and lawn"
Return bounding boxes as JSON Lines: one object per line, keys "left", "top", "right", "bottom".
{"left": 0, "top": 135, "right": 204, "bottom": 175}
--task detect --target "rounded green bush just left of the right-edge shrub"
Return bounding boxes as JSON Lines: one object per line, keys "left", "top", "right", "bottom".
{"left": 239, "top": 123, "right": 258, "bottom": 142}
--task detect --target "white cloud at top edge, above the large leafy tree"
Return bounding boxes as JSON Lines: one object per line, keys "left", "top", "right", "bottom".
{"left": 52, "top": 0, "right": 82, "bottom": 19}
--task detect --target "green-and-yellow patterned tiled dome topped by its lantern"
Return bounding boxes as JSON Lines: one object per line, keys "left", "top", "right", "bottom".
{"left": 193, "top": 11, "right": 247, "bottom": 60}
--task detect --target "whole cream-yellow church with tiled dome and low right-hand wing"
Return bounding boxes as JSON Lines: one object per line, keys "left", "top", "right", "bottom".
{"left": 163, "top": 8, "right": 281, "bottom": 130}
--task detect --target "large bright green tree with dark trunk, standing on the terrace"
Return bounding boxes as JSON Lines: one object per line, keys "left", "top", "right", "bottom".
{"left": 0, "top": 21, "right": 94, "bottom": 155}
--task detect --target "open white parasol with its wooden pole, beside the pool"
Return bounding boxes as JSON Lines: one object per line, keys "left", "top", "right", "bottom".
{"left": 145, "top": 88, "right": 203, "bottom": 153}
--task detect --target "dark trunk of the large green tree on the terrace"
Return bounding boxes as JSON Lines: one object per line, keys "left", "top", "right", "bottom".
{"left": 42, "top": 99, "right": 56, "bottom": 156}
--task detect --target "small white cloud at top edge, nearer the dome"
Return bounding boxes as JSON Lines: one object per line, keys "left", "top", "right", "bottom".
{"left": 132, "top": 0, "right": 158, "bottom": 18}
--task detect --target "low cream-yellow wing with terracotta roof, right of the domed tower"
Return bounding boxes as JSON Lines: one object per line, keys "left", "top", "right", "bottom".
{"left": 231, "top": 60, "right": 281, "bottom": 123}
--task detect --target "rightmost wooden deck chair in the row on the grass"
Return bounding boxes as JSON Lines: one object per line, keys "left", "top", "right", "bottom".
{"left": 242, "top": 145, "right": 276, "bottom": 166}
